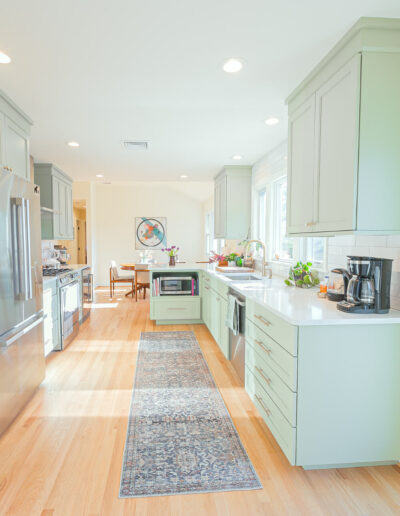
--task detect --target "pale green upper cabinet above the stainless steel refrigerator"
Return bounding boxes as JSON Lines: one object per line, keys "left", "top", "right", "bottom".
{"left": 0, "top": 91, "right": 32, "bottom": 181}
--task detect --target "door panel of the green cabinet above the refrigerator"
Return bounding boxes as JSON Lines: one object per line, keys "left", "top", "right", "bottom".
{"left": 4, "top": 117, "right": 30, "bottom": 180}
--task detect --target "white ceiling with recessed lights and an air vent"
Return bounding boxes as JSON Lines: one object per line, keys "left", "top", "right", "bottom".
{"left": 0, "top": 0, "right": 400, "bottom": 181}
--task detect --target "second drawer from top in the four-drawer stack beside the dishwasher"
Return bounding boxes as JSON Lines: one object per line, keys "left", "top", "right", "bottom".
{"left": 246, "top": 319, "right": 297, "bottom": 391}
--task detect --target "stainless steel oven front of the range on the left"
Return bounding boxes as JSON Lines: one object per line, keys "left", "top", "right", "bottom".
{"left": 59, "top": 272, "right": 80, "bottom": 350}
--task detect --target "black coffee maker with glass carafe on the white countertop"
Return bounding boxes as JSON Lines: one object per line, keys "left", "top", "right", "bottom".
{"left": 337, "top": 256, "right": 393, "bottom": 314}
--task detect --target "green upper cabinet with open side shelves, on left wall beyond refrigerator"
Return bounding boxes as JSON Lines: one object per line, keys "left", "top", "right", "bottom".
{"left": 35, "top": 163, "right": 74, "bottom": 240}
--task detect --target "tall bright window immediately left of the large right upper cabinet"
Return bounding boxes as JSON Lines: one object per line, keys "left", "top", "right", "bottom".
{"left": 272, "top": 176, "right": 294, "bottom": 260}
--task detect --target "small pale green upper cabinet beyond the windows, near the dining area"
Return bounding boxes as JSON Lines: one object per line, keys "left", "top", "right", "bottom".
{"left": 214, "top": 166, "right": 251, "bottom": 239}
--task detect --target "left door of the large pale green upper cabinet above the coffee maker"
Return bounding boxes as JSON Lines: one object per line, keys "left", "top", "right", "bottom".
{"left": 287, "top": 95, "right": 315, "bottom": 234}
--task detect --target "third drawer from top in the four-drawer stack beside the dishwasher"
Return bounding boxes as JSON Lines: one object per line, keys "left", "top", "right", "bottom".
{"left": 246, "top": 342, "right": 297, "bottom": 426}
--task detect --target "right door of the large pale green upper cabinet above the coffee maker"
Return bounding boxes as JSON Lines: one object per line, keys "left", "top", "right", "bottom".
{"left": 313, "top": 54, "right": 361, "bottom": 231}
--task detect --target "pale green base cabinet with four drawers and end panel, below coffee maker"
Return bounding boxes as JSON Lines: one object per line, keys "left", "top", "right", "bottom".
{"left": 245, "top": 300, "right": 400, "bottom": 469}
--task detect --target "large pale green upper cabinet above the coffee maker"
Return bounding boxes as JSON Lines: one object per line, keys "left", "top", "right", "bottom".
{"left": 287, "top": 18, "right": 400, "bottom": 235}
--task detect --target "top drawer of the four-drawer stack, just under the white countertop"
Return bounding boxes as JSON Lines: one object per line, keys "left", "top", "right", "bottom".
{"left": 246, "top": 300, "right": 297, "bottom": 356}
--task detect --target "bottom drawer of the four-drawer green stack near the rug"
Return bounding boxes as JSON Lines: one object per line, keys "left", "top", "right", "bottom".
{"left": 245, "top": 367, "right": 296, "bottom": 465}
